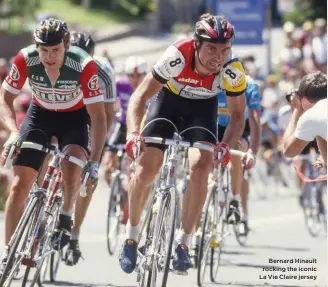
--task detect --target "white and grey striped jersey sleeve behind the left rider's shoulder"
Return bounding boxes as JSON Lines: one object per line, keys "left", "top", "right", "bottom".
{"left": 93, "top": 56, "right": 116, "bottom": 103}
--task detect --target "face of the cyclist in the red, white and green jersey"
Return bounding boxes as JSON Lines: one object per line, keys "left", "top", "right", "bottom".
{"left": 38, "top": 43, "right": 65, "bottom": 70}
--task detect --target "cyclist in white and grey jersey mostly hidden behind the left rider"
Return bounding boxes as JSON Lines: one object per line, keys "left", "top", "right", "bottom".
{"left": 65, "top": 31, "right": 116, "bottom": 266}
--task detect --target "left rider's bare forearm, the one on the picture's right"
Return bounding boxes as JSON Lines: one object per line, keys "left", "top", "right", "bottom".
{"left": 90, "top": 112, "right": 107, "bottom": 162}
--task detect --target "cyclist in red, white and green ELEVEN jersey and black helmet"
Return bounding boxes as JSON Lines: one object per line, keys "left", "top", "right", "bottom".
{"left": 0, "top": 18, "right": 106, "bottom": 275}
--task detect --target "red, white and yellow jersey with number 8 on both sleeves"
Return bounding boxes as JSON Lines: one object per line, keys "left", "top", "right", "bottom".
{"left": 152, "top": 39, "right": 246, "bottom": 99}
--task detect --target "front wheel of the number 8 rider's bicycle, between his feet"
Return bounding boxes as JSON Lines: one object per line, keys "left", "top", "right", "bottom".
{"left": 150, "top": 188, "right": 177, "bottom": 287}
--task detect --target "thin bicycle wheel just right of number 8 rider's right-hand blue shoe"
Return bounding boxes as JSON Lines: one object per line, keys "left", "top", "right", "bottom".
{"left": 197, "top": 187, "right": 215, "bottom": 287}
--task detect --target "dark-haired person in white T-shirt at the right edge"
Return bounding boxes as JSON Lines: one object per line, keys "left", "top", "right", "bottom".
{"left": 282, "top": 71, "right": 328, "bottom": 169}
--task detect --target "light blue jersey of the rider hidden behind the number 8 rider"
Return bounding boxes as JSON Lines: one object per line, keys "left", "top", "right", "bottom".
{"left": 217, "top": 76, "right": 261, "bottom": 127}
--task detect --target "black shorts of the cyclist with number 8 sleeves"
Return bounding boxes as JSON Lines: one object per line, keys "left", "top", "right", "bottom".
{"left": 142, "top": 87, "right": 217, "bottom": 151}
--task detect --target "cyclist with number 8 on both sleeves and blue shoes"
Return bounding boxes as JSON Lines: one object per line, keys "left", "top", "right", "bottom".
{"left": 119, "top": 13, "right": 246, "bottom": 273}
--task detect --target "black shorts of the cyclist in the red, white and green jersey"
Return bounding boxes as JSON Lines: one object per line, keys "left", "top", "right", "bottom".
{"left": 13, "top": 104, "right": 91, "bottom": 171}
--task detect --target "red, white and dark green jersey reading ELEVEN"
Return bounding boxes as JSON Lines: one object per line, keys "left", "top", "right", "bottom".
{"left": 2, "top": 45, "right": 104, "bottom": 112}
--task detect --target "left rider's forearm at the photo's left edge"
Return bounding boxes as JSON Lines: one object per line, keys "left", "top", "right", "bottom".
{"left": 0, "top": 88, "right": 19, "bottom": 133}
